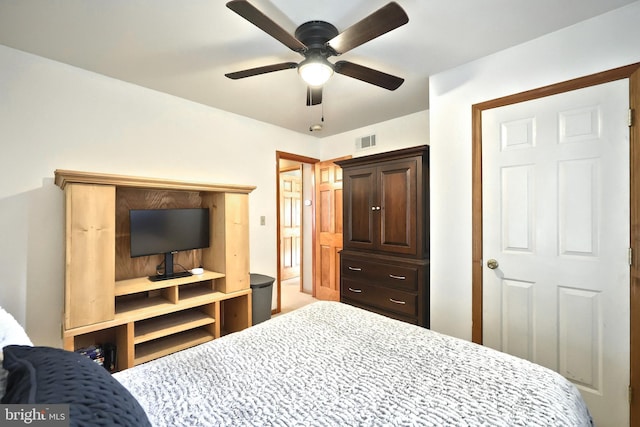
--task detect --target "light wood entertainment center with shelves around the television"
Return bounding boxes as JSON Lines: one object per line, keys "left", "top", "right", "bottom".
{"left": 55, "top": 170, "right": 255, "bottom": 370}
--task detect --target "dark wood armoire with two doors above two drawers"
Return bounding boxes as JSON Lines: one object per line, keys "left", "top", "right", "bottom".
{"left": 336, "top": 145, "right": 429, "bottom": 328}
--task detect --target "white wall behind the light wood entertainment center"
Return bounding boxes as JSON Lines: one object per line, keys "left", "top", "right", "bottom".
{"left": 0, "top": 46, "right": 320, "bottom": 345}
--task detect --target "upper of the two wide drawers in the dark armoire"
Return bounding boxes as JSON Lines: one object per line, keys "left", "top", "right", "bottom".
{"left": 340, "top": 256, "right": 418, "bottom": 291}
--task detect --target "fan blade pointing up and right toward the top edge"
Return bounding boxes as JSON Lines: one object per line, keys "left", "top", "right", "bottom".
{"left": 327, "top": 2, "right": 409, "bottom": 55}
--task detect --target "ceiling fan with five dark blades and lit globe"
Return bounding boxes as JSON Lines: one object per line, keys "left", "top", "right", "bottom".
{"left": 225, "top": 0, "right": 409, "bottom": 106}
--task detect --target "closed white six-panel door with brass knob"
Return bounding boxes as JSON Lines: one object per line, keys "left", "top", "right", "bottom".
{"left": 482, "top": 80, "right": 630, "bottom": 427}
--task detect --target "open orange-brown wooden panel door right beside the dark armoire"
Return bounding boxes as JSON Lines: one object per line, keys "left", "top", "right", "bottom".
{"left": 313, "top": 157, "right": 346, "bottom": 301}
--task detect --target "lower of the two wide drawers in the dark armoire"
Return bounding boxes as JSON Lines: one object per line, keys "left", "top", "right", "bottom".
{"left": 340, "top": 276, "right": 418, "bottom": 316}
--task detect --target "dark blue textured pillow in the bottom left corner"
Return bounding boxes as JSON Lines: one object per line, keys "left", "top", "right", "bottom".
{"left": 2, "top": 345, "right": 151, "bottom": 426}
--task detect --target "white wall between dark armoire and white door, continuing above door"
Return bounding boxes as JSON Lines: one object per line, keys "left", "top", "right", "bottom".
{"left": 429, "top": 2, "right": 640, "bottom": 339}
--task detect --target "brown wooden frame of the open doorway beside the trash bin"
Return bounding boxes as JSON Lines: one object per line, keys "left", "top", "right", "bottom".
{"left": 271, "top": 150, "right": 320, "bottom": 314}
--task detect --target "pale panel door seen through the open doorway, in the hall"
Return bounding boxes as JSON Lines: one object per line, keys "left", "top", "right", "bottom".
{"left": 280, "top": 168, "right": 302, "bottom": 280}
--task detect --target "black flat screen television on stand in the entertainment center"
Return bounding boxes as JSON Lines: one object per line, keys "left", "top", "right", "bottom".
{"left": 129, "top": 208, "right": 210, "bottom": 281}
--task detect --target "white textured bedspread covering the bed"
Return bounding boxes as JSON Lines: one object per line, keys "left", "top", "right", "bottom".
{"left": 114, "top": 302, "right": 591, "bottom": 427}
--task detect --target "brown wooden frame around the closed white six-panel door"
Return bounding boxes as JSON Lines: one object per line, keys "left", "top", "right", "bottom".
{"left": 471, "top": 63, "right": 640, "bottom": 426}
